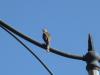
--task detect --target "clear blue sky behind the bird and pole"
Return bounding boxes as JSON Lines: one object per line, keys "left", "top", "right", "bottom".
{"left": 0, "top": 0, "right": 100, "bottom": 75}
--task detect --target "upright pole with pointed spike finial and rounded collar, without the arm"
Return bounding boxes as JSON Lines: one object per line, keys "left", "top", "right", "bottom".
{"left": 84, "top": 34, "right": 100, "bottom": 75}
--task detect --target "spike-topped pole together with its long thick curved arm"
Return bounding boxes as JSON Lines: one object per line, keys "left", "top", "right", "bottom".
{"left": 0, "top": 20, "right": 100, "bottom": 75}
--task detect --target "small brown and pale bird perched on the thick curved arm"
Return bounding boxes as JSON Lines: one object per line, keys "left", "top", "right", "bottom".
{"left": 43, "top": 29, "right": 51, "bottom": 52}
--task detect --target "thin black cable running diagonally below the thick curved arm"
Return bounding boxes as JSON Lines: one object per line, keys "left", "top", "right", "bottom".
{"left": 0, "top": 26, "right": 53, "bottom": 75}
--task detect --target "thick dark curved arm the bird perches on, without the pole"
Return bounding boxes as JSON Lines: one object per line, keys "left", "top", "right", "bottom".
{"left": 0, "top": 20, "right": 84, "bottom": 60}
